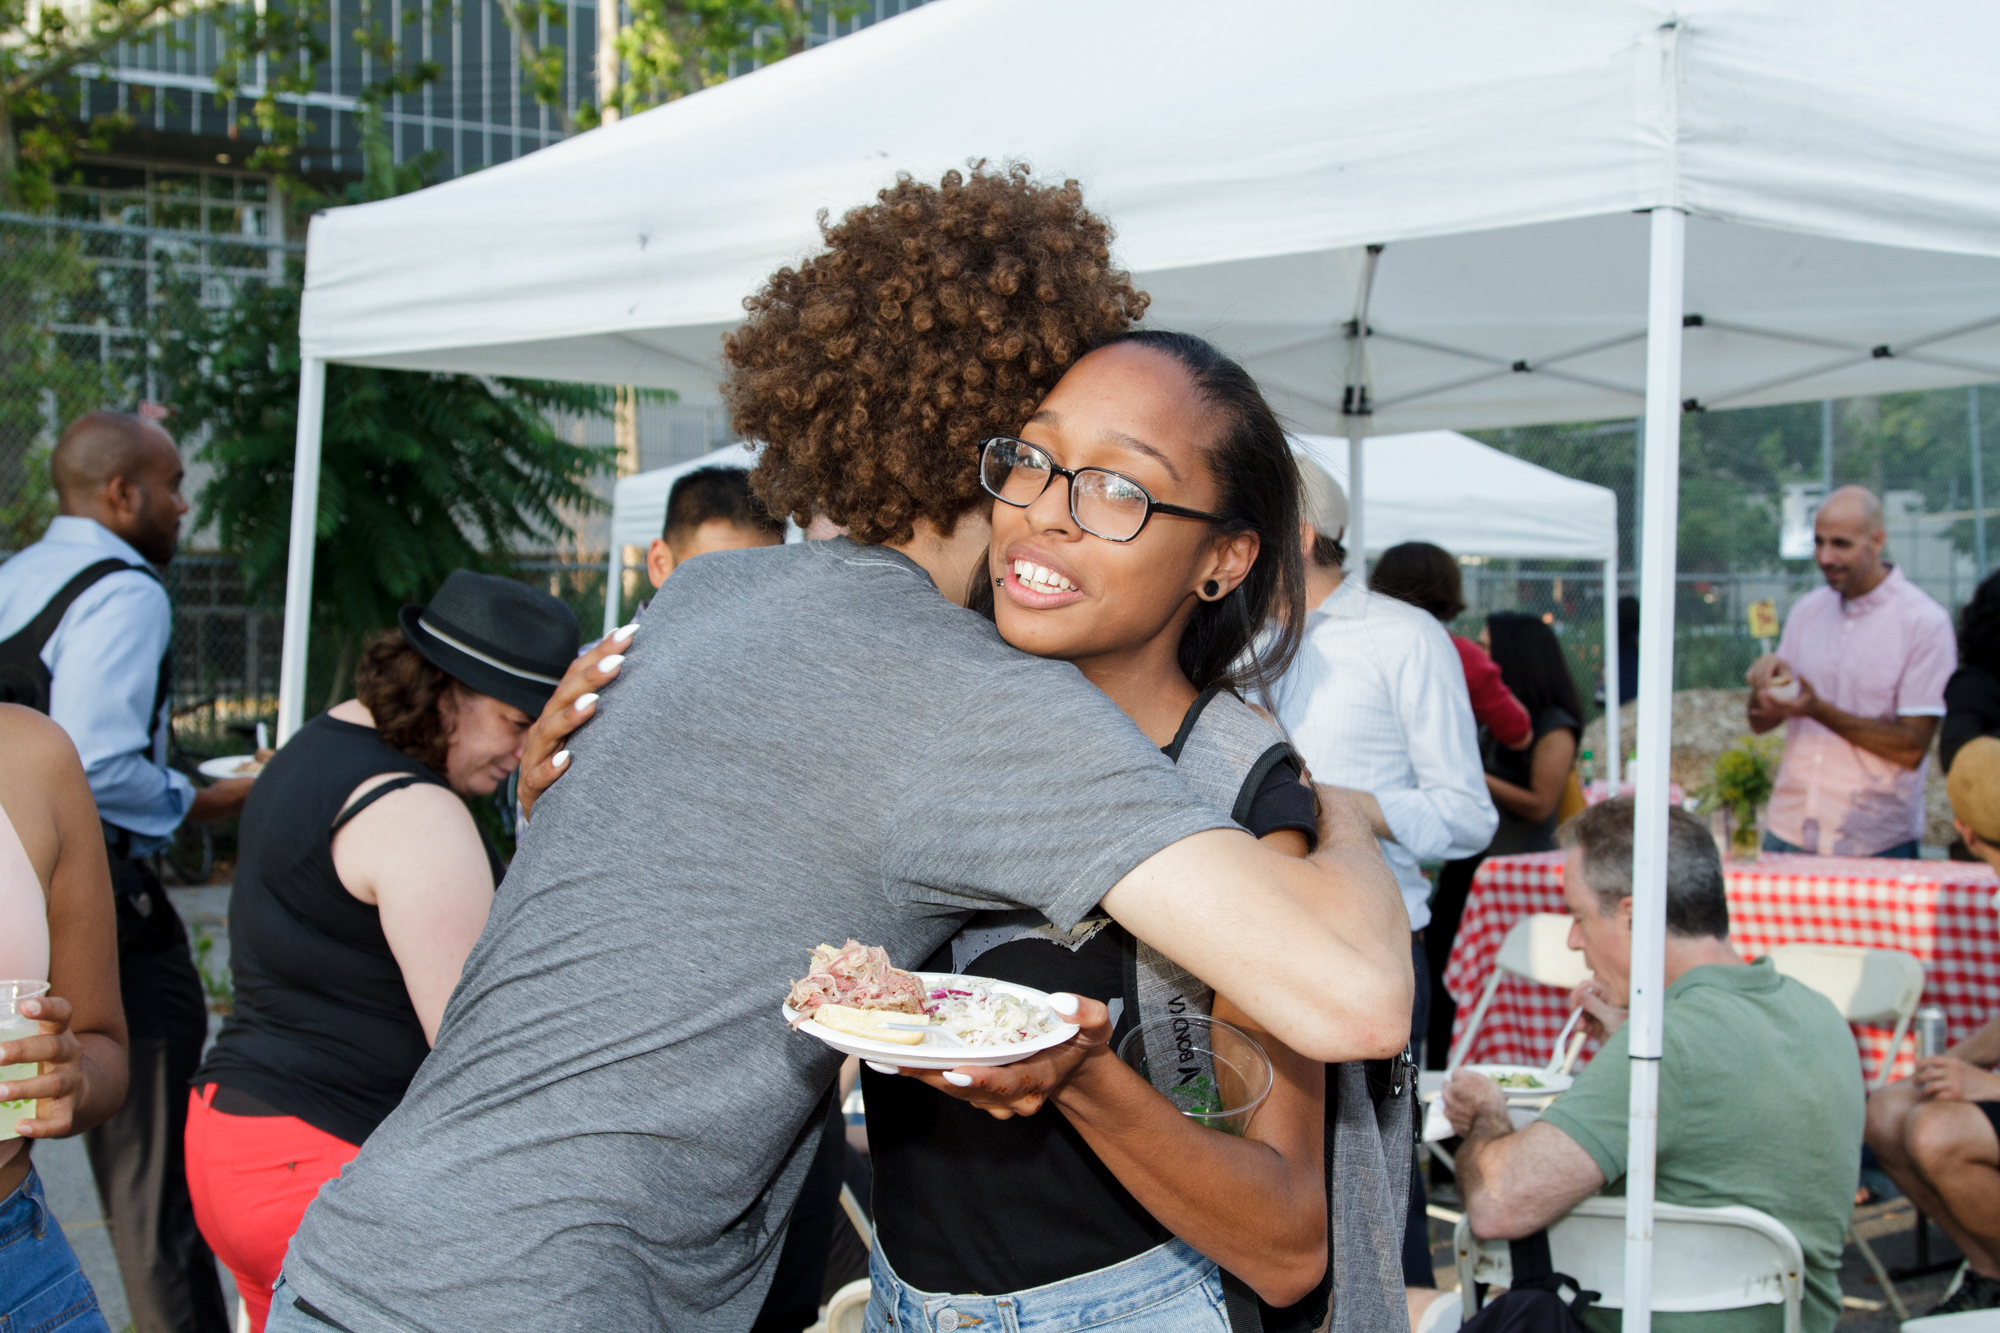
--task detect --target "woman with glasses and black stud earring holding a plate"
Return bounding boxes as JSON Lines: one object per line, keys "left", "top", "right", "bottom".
{"left": 864, "top": 332, "right": 1352, "bottom": 1333}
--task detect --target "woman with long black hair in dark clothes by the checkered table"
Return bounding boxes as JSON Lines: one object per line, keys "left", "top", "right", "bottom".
{"left": 1424, "top": 610, "right": 1584, "bottom": 1069}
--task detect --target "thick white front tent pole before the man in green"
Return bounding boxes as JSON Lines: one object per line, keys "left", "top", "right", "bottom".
{"left": 1624, "top": 208, "right": 1688, "bottom": 1333}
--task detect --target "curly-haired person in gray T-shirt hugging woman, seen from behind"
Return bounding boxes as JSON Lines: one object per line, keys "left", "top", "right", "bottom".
{"left": 270, "top": 168, "right": 1412, "bottom": 1333}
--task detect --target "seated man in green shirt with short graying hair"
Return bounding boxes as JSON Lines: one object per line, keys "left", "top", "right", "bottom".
{"left": 1444, "top": 799, "right": 1864, "bottom": 1333}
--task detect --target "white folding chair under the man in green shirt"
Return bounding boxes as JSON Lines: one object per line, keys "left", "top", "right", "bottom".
{"left": 1452, "top": 1197, "right": 1806, "bottom": 1333}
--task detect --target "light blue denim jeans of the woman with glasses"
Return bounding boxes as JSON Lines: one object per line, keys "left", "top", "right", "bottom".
{"left": 864, "top": 1241, "right": 1230, "bottom": 1333}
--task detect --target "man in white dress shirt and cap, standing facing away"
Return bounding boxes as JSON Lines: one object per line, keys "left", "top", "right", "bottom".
{"left": 1270, "top": 458, "right": 1500, "bottom": 1287}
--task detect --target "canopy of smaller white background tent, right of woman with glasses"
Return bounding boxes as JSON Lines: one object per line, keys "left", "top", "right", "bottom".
{"left": 1292, "top": 430, "right": 1618, "bottom": 560}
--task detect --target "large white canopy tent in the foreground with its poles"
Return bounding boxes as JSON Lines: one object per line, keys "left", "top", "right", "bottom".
{"left": 280, "top": 0, "right": 2000, "bottom": 1329}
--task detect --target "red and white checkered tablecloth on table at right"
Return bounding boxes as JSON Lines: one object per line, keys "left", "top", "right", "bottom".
{"left": 1444, "top": 853, "right": 2000, "bottom": 1077}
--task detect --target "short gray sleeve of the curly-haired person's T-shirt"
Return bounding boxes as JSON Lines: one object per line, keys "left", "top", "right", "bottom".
{"left": 882, "top": 662, "right": 1248, "bottom": 929}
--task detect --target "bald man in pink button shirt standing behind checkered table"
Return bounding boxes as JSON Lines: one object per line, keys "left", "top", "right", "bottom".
{"left": 1746, "top": 486, "right": 1958, "bottom": 857}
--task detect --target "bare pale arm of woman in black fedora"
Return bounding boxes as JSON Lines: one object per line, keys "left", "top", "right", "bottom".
{"left": 334, "top": 775, "right": 494, "bottom": 1043}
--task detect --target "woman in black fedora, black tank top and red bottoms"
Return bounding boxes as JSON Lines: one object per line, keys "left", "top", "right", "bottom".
{"left": 188, "top": 570, "right": 578, "bottom": 1329}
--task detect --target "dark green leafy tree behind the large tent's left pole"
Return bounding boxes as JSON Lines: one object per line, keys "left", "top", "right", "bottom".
{"left": 156, "top": 116, "right": 614, "bottom": 691}
